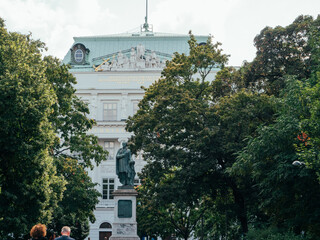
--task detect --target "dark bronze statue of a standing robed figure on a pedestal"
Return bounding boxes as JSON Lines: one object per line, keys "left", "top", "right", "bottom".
{"left": 116, "top": 142, "right": 136, "bottom": 186}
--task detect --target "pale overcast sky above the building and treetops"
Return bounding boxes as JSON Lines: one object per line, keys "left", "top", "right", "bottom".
{"left": 0, "top": 0, "right": 320, "bottom": 66}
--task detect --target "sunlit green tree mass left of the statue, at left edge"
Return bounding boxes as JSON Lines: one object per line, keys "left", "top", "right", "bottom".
{"left": 0, "top": 17, "right": 107, "bottom": 239}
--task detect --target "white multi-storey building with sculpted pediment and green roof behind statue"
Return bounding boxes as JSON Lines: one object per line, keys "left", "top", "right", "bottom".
{"left": 63, "top": 23, "right": 217, "bottom": 240}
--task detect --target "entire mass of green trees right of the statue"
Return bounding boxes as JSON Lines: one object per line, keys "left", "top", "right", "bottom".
{"left": 127, "top": 16, "right": 320, "bottom": 239}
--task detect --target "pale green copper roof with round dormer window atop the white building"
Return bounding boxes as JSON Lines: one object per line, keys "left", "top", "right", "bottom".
{"left": 63, "top": 32, "right": 209, "bottom": 72}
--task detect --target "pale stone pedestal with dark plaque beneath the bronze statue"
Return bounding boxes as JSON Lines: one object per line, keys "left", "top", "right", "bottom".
{"left": 110, "top": 186, "right": 140, "bottom": 240}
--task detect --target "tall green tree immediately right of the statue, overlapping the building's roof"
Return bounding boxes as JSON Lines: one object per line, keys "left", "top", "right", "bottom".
{"left": 127, "top": 35, "right": 227, "bottom": 239}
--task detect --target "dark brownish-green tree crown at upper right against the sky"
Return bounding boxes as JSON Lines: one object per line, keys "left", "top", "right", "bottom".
{"left": 241, "top": 15, "right": 320, "bottom": 95}
